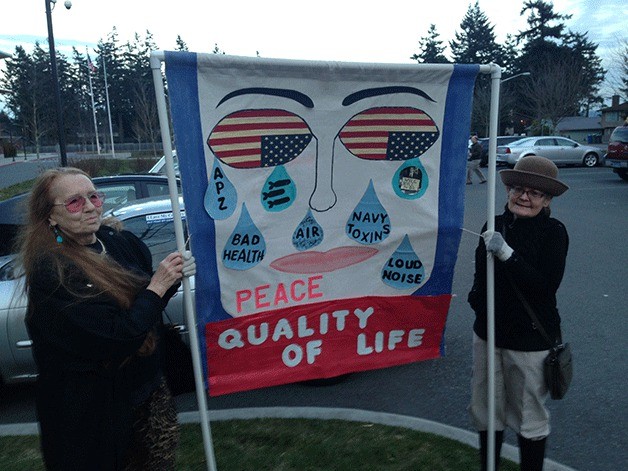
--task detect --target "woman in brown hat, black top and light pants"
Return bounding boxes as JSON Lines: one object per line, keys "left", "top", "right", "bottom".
{"left": 468, "top": 156, "right": 569, "bottom": 471}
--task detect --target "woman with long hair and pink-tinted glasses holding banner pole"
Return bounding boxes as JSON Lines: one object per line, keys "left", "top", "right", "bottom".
{"left": 20, "top": 168, "right": 195, "bottom": 471}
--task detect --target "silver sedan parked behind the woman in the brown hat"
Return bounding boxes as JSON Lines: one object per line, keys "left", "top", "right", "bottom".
{"left": 497, "top": 136, "right": 604, "bottom": 167}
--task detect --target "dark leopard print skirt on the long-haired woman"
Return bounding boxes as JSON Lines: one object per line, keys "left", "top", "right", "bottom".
{"left": 124, "top": 380, "right": 179, "bottom": 471}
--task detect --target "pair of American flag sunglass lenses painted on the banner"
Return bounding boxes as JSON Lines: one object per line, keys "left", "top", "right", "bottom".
{"left": 207, "top": 107, "right": 439, "bottom": 168}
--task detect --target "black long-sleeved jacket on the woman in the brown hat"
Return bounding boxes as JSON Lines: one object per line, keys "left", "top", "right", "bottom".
{"left": 468, "top": 209, "right": 569, "bottom": 351}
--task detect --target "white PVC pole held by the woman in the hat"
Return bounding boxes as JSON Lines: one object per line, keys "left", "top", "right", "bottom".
{"left": 486, "top": 64, "right": 502, "bottom": 471}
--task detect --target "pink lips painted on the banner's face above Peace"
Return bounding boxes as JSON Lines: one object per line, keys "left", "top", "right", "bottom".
{"left": 270, "top": 247, "right": 379, "bottom": 274}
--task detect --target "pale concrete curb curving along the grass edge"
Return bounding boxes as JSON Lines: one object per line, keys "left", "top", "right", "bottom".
{"left": 0, "top": 407, "right": 576, "bottom": 471}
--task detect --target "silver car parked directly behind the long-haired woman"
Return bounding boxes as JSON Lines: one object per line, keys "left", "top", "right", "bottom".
{"left": 0, "top": 197, "right": 194, "bottom": 384}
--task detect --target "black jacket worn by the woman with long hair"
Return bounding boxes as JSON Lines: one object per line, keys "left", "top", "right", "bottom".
{"left": 27, "top": 228, "right": 169, "bottom": 471}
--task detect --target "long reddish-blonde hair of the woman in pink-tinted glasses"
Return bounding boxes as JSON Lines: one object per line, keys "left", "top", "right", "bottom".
{"left": 19, "top": 167, "right": 149, "bottom": 309}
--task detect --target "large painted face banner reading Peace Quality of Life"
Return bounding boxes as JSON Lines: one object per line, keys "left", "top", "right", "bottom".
{"left": 165, "top": 52, "right": 479, "bottom": 395}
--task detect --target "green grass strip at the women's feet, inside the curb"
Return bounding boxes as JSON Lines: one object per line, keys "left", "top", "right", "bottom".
{"left": 0, "top": 419, "right": 519, "bottom": 471}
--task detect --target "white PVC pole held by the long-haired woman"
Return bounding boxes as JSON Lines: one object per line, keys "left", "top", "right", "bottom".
{"left": 150, "top": 52, "right": 217, "bottom": 471}
